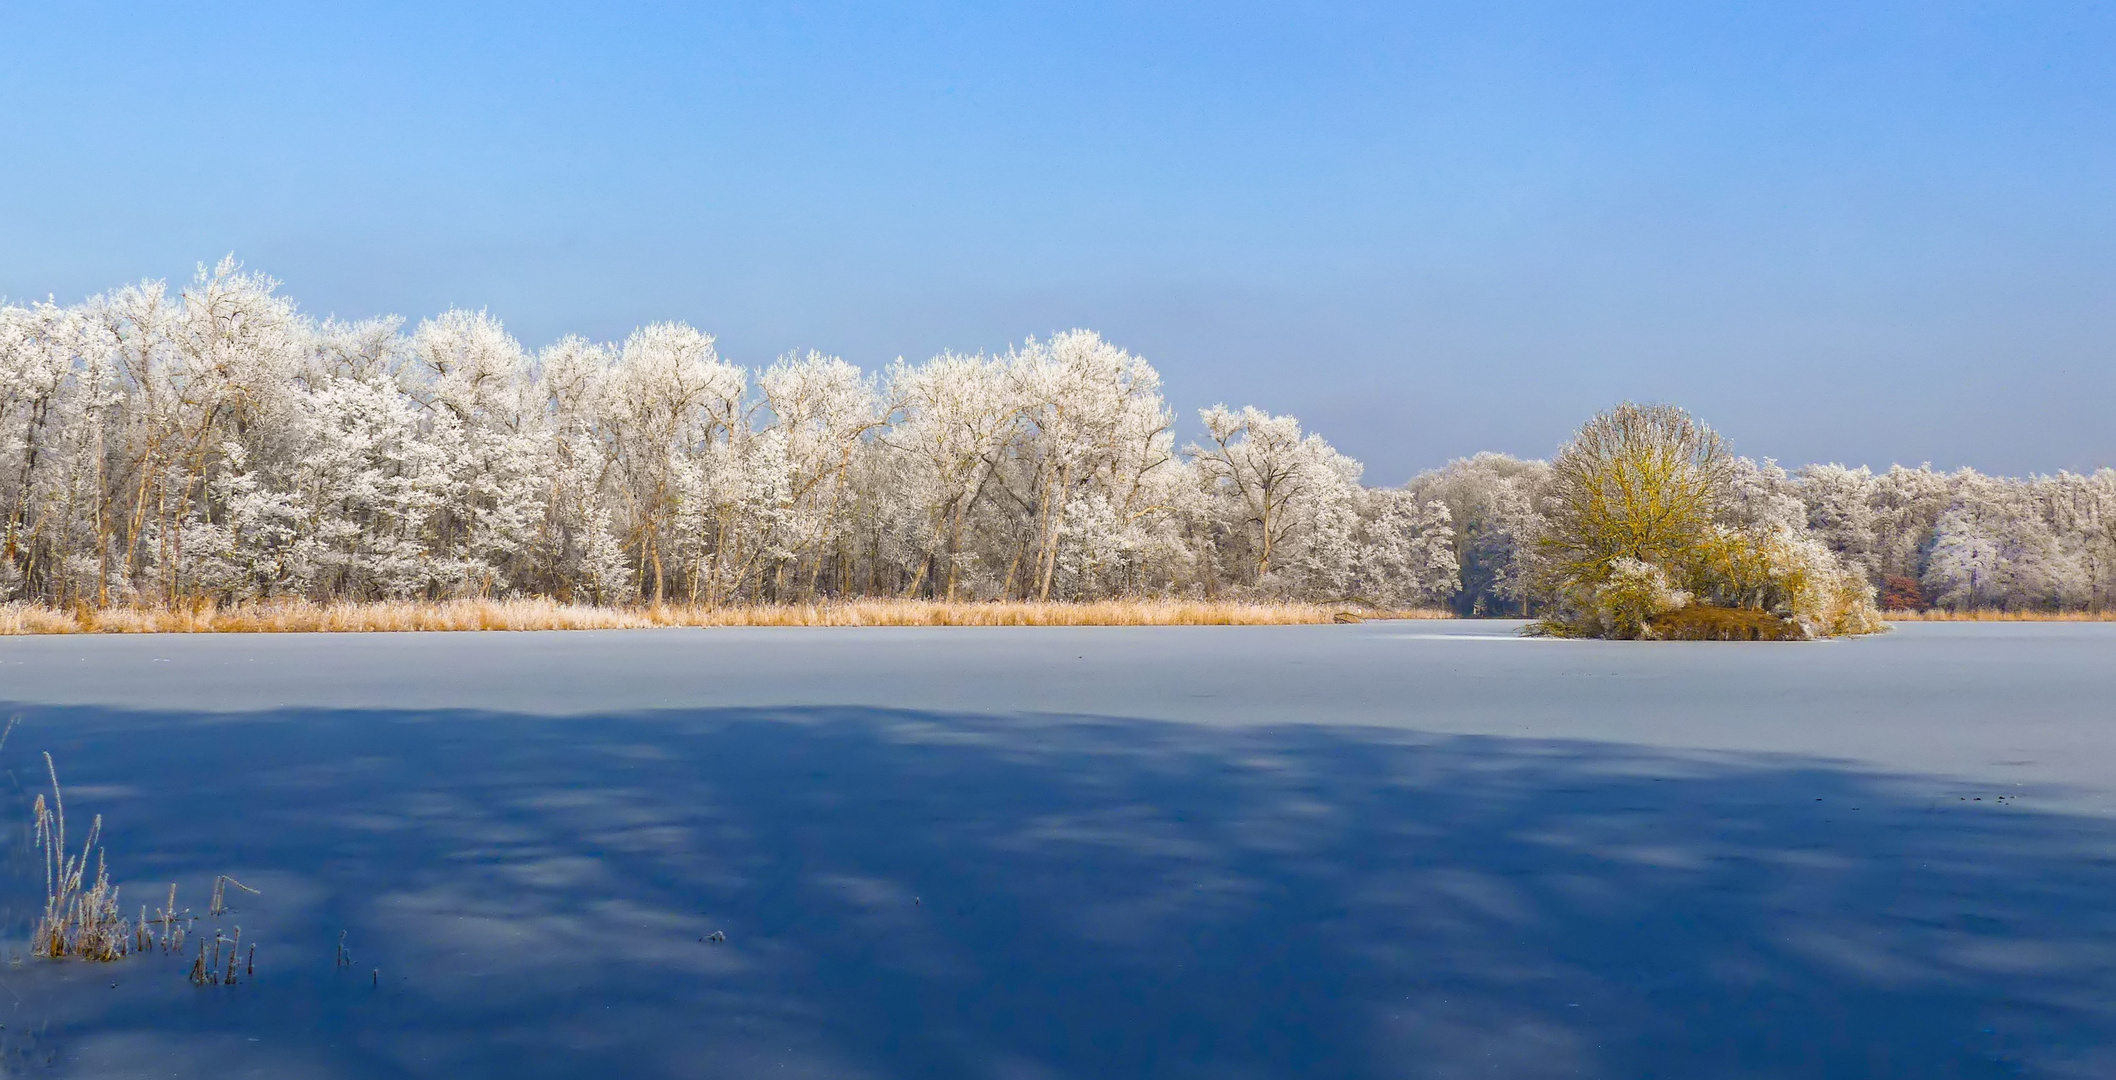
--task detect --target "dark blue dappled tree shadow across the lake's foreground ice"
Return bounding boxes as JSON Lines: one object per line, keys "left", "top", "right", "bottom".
{"left": 0, "top": 705, "right": 2116, "bottom": 1080}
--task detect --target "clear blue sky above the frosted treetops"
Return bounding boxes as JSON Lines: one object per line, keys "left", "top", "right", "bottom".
{"left": 0, "top": 0, "right": 2116, "bottom": 483}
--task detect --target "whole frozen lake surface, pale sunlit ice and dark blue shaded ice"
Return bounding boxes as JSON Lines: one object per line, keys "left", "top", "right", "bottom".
{"left": 0, "top": 623, "right": 2116, "bottom": 1080}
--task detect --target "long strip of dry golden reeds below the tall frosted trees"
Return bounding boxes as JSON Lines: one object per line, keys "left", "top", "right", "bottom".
{"left": 0, "top": 599, "right": 1449, "bottom": 635}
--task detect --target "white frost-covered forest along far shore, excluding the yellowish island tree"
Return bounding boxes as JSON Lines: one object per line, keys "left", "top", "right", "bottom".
{"left": 0, "top": 260, "right": 2116, "bottom": 614}
